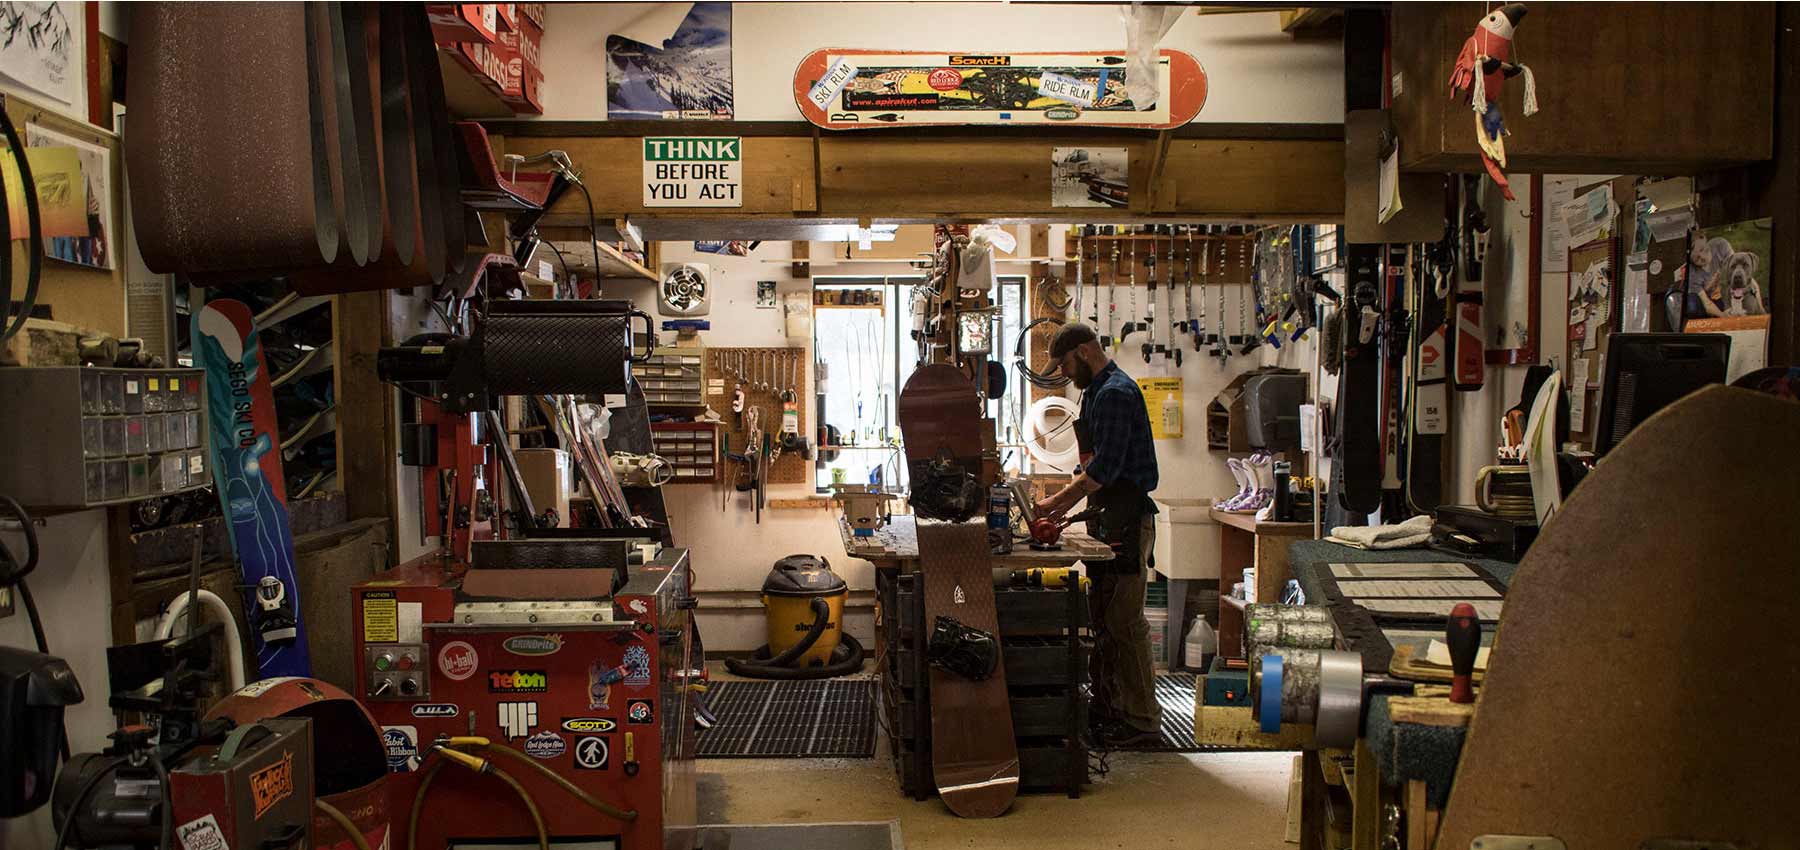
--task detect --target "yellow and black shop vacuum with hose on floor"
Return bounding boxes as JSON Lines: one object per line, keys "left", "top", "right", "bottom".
{"left": 725, "top": 555, "right": 862, "bottom": 679}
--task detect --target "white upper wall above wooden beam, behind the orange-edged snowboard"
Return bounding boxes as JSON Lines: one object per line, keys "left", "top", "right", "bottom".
{"left": 544, "top": 2, "right": 1343, "bottom": 124}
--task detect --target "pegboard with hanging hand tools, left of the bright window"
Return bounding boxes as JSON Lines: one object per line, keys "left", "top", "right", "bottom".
{"left": 706, "top": 348, "right": 812, "bottom": 484}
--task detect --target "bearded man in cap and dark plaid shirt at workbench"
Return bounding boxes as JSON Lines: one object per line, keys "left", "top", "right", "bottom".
{"left": 1037, "top": 322, "right": 1161, "bottom": 747}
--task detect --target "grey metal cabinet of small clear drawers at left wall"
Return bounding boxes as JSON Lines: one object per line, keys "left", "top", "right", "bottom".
{"left": 0, "top": 366, "right": 212, "bottom": 508}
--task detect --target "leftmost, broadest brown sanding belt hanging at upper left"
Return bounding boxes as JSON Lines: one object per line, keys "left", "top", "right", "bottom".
{"left": 124, "top": 2, "right": 328, "bottom": 274}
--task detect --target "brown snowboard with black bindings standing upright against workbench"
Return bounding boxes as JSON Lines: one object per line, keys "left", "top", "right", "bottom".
{"left": 896, "top": 364, "right": 1019, "bottom": 818}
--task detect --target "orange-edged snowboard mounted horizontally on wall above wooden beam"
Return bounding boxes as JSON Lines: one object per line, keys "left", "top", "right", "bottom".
{"left": 794, "top": 49, "right": 1206, "bottom": 130}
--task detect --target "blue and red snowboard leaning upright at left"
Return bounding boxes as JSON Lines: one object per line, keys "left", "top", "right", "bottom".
{"left": 194, "top": 299, "right": 311, "bottom": 677}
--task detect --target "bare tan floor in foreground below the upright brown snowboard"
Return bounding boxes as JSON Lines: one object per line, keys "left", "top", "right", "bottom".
{"left": 697, "top": 668, "right": 1294, "bottom": 850}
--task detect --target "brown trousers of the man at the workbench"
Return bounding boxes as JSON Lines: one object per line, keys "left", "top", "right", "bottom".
{"left": 1087, "top": 513, "right": 1163, "bottom": 731}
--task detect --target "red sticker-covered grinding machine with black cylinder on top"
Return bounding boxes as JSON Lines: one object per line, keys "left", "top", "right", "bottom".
{"left": 351, "top": 293, "right": 702, "bottom": 850}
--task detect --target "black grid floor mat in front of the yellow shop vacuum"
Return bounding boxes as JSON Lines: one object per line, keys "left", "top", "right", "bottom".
{"left": 698, "top": 679, "right": 878, "bottom": 758}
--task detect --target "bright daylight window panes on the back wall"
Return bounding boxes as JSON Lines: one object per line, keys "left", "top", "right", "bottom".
{"left": 812, "top": 276, "right": 1030, "bottom": 492}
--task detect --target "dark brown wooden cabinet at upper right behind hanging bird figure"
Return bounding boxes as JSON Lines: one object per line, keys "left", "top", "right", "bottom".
{"left": 1390, "top": 2, "right": 1777, "bottom": 175}
